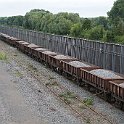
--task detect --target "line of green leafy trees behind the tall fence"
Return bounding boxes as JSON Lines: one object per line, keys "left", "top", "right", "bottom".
{"left": 0, "top": 0, "right": 124, "bottom": 44}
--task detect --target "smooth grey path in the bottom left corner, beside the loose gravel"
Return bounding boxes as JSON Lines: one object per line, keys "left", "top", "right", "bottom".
{"left": 0, "top": 61, "right": 46, "bottom": 124}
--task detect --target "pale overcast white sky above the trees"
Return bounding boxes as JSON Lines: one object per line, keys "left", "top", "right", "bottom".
{"left": 0, "top": 0, "right": 115, "bottom": 17}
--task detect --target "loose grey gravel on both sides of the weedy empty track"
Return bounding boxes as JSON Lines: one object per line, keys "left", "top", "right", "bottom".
{"left": 0, "top": 42, "right": 124, "bottom": 124}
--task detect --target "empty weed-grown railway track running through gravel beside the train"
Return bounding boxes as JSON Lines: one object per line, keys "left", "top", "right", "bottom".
{"left": 7, "top": 52, "right": 116, "bottom": 124}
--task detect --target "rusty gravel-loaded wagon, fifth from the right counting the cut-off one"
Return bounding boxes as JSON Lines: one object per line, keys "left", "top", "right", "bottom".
{"left": 41, "top": 51, "right": 57, "bottom": 66}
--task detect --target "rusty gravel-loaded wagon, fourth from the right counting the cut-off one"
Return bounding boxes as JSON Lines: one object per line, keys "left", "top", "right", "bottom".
{"left": 50, "top": 55, "right": 77, "bottom": 72}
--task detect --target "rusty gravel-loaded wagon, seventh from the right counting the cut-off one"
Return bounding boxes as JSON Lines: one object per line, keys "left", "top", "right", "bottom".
{"left": 24, "top": 43, "right": 41, "bottom": 57}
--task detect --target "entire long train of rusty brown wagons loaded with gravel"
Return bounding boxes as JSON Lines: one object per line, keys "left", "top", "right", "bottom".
{"left": 0, "top": 33, "right": 124, "bottom": 110}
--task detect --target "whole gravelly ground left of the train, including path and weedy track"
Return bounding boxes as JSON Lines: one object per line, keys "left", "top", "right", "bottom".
{"left": 0, "top": 41, "right": 124, "bottom": 124}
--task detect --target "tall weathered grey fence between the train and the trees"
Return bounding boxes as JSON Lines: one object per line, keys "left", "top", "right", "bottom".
{"left": 0, "top": 26, "right": 124, "bottom": 74}
